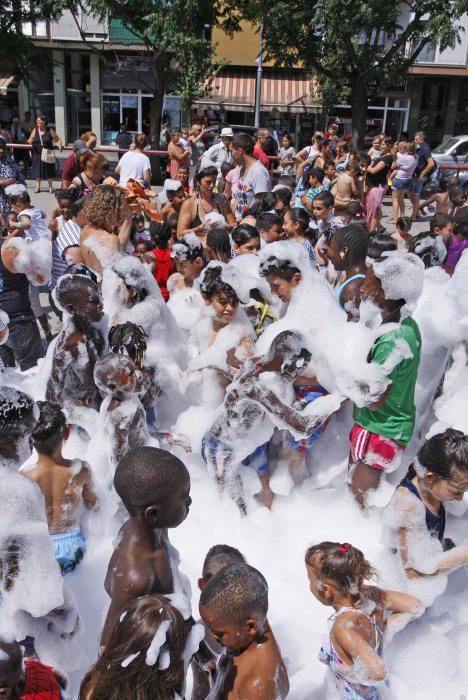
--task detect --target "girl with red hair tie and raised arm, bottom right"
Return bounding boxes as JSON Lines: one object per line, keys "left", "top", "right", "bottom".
{"left": 305, "top": 542, "right": 424, "bottom": 700}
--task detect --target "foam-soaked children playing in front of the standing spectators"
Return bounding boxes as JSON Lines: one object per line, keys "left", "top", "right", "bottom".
{"left": 0, "top": 130, "right": 468, "bottom": 700}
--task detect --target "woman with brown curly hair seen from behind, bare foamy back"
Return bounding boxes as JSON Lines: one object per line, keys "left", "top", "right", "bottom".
{"left": 80, "top": 185, "right": 132, "bottom": 273}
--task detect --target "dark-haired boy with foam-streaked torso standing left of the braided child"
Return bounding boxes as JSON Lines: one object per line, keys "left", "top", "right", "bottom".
{"left": 46, "top": 274, "right": 104, "bottom": 407}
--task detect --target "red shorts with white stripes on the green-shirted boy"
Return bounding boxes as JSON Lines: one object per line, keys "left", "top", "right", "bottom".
{"left": 349, "top": 423, "right": 406, "bottom": 472}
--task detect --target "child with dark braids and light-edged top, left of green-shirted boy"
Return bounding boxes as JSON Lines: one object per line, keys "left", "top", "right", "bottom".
{"left": 325, "top": 224, "right": 369, "bottom": 321}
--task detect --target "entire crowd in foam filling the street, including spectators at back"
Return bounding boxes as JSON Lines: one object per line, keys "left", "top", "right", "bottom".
{"left": 0, "top": 118, "right": 468, "bottom": 700}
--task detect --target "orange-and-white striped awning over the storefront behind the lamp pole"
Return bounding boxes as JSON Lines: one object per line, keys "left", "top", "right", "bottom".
{"left": 196, "top": 71, "right": 321, "bottom": 112}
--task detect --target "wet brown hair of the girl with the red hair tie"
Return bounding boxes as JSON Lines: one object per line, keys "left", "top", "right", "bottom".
{"left": 305, "top": 542, "right": 376, "bottom": 600}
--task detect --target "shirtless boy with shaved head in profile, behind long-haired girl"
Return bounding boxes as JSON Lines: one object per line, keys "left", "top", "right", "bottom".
{"left": 101, "top": 447, "right": 192, "bottom": 646}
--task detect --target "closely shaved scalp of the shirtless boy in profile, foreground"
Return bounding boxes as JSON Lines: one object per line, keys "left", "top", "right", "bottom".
{"left": 114, "top": 447, "right": 189, "bottom": 515}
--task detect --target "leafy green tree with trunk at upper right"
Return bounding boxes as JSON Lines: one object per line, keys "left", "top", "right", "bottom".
{"left": 221, "top": 0, "right": 468, "bottom": 143}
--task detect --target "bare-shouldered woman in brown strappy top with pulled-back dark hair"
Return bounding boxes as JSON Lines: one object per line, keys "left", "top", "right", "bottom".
{"left": 177, "top": 166, "right": 236, "bottom": 238}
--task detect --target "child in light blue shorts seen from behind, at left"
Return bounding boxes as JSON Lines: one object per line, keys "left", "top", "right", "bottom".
{"left": 25, "top": 401, "right": 96, "bottom": 574}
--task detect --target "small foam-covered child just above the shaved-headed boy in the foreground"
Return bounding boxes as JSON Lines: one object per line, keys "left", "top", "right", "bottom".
{"left": 94, "top": 353, "right": 150, "bottom": 472}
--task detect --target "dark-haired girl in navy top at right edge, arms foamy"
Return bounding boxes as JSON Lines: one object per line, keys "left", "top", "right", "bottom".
{"left": 383, "top": 428, "right": 468, "bottom": 578}
